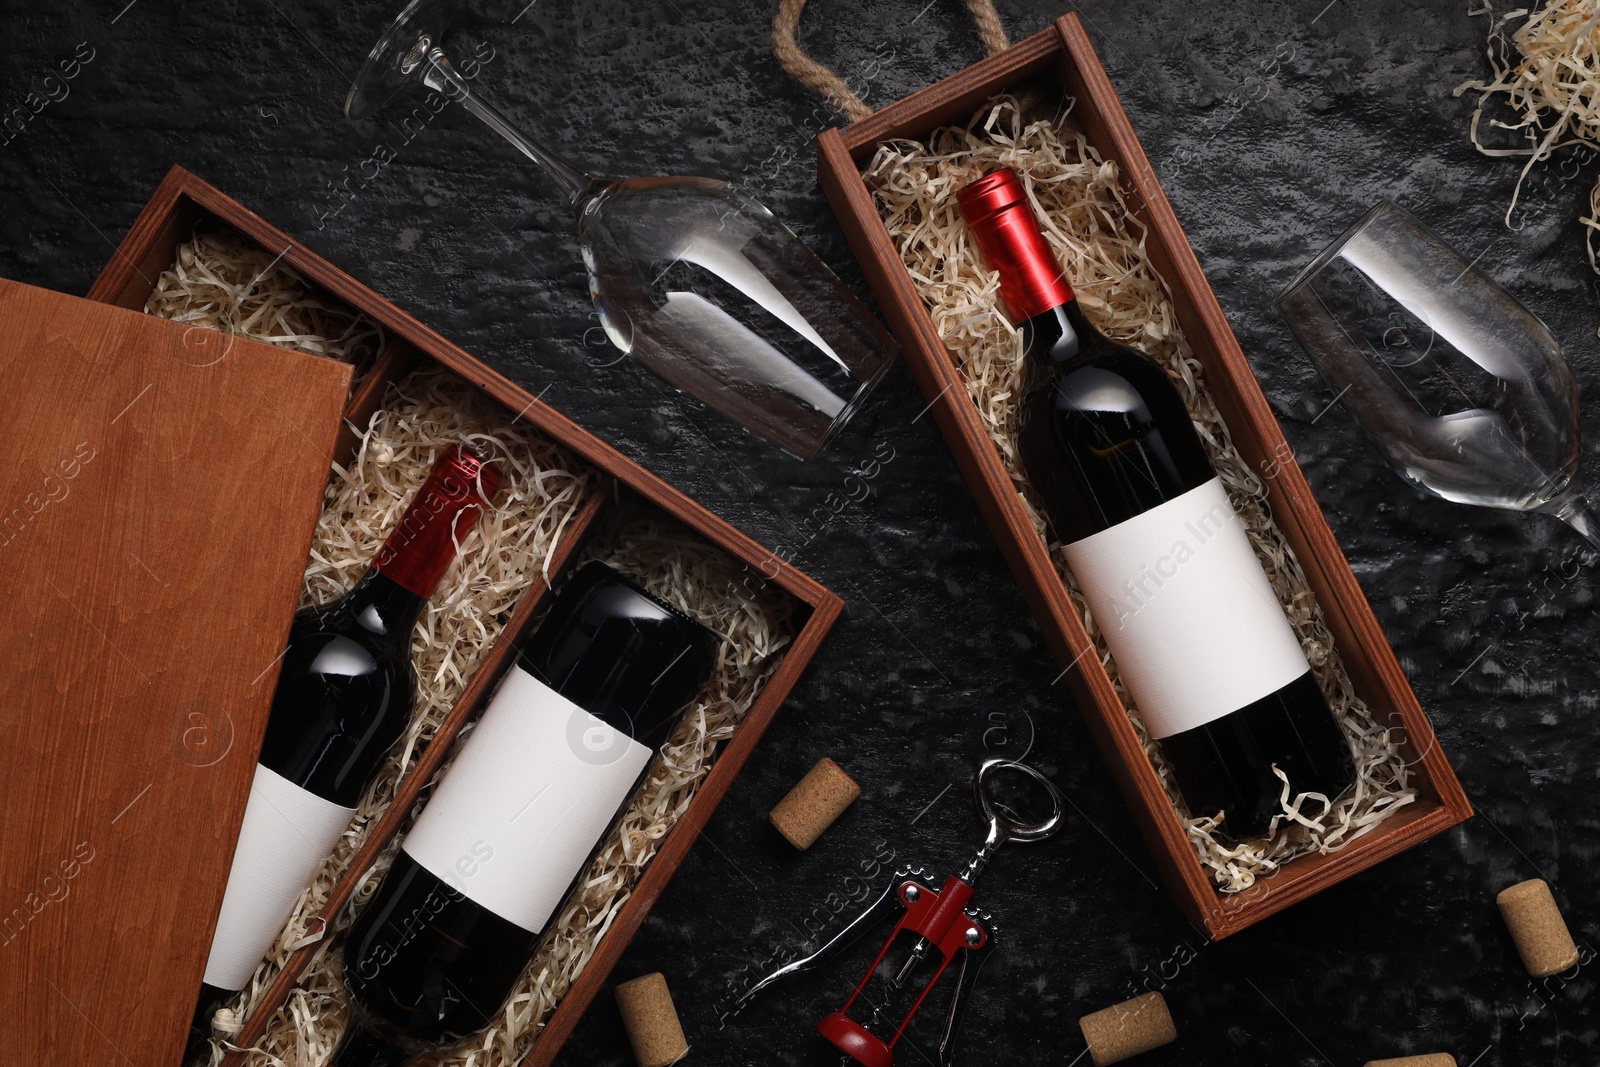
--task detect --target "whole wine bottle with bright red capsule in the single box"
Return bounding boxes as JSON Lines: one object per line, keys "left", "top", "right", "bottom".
{"left": 957, "top": 170, "right": 1354, "bottom": 841}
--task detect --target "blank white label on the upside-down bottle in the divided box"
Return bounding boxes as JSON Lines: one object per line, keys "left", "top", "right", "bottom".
{"left": 402, "top": 664, "right": 654, "bottom": 933}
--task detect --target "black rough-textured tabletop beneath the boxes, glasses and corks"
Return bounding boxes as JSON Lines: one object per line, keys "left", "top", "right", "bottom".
{"left": 0, "top": 0, "right": 1600, "bottom": 1067}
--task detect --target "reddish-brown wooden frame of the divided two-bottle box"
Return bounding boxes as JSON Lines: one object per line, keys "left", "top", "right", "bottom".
{"left": 90, "top": 166, "right": 842, "bottom": 1067}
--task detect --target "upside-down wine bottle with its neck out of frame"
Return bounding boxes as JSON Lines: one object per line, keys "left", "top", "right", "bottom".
{"left": 330, "top": 563, "right": 717, "bottom": 1067}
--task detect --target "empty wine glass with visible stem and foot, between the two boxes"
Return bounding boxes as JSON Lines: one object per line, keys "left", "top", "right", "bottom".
{"left": 344, "top": 0, "right": 896, "bottom": 459}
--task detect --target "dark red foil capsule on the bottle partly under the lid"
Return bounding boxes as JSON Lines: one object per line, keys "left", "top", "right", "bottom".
{"left": 373, "top": 445, "right": 501, "bottom": 598}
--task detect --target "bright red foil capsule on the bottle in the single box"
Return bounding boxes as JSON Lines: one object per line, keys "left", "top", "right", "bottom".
{"left": 955, "top": 166, "right": 1072, "bottom": 325}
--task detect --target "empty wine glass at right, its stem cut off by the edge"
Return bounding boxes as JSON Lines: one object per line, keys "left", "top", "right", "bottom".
{"left": 1278, "top": 200, "right": 1600, "bottom": 549}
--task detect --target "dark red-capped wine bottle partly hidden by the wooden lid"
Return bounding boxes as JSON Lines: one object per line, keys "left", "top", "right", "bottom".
{"left": 189, "top": 446, "right": 499, "bottom": 1057}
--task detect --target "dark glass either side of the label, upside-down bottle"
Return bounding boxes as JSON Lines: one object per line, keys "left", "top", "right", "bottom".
{"left": 331, "top": 563, "right": 717, "bottom": 1067}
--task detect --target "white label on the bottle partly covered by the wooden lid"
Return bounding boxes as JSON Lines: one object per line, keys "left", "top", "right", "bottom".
{"left": 205, "top": 763, "right": 355, "bottom": 989}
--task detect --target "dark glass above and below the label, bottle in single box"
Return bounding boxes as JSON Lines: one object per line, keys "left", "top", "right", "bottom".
{"left": 1018, "top": 299, "right": 1352, "bottom": 840}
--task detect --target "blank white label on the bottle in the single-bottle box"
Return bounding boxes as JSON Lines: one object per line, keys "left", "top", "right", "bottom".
{"left": 1064, "top": 478, "right": 1310, "bottom": 737}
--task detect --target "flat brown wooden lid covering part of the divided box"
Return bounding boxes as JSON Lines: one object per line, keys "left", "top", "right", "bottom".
{"left": 0, "top": 280, "right": 350, "bottom": 1064}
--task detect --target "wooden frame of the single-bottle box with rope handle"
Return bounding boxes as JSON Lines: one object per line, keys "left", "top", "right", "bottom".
{"left": 818, "top": 14, "right": 1472, "bottom": 937}
